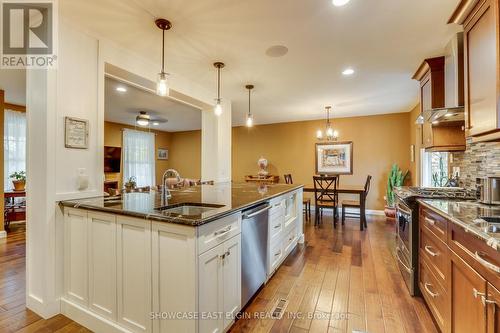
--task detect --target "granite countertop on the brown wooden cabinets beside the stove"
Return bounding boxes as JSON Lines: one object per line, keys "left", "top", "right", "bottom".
{"left": 417, "top": 198, "right": 500, "bottom": 251}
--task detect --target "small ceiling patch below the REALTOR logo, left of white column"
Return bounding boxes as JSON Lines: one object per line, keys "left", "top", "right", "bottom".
{"left": 0, "top": 69, "right": 26, "bottom": 105}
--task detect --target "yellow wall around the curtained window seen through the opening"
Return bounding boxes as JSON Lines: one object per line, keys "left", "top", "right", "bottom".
{"left": 104, "top": 121, "right": 172, "bottom": 187}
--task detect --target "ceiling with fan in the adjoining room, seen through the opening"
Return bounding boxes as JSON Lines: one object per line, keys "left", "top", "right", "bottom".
{"left": 104, "top": 77, "right": 201, "bottom": 132}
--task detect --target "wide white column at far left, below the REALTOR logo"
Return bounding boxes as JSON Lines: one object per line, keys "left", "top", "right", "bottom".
{"left": 26, "top": 70, "right": 59, "bottom": 318}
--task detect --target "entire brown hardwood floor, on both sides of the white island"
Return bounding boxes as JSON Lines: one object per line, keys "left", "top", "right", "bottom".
{"left": 0, "top": 215, "right": 437, "bottom": 333}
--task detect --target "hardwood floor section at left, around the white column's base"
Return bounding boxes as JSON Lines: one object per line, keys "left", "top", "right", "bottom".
{"left": 0, "top": 224, "right": 90, "bottom": 333}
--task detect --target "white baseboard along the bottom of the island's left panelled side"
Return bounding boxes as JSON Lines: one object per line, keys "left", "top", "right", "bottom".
{"left": 61, "top": 298, "right": 133, "bottom": 333}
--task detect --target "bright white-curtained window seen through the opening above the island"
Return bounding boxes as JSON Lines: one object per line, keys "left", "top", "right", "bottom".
{"left": 123, "top": 129, "right": 155, "bottom": 187}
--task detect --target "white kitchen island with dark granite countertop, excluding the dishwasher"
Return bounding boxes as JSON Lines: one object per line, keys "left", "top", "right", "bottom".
{"left": 61, "top": 183, "right": 304, "bottom": 332}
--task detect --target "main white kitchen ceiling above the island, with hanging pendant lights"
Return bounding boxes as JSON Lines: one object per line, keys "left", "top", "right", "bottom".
{"left": 60, "top": 0, "right": 459, "bottom": 125}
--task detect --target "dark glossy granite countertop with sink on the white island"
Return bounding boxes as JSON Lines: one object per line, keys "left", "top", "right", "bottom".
{"left": 60, "top": 182, "right": 303, "bottom": 226}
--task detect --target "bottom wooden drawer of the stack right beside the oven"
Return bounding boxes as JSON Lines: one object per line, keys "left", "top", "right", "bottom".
{"left": 419, "top": 258, "right": 448, "bottom": 332}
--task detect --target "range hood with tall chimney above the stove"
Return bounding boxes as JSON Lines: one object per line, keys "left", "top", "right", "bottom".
{"left": 417, "top": 32, "right": 465, "bottom": 126}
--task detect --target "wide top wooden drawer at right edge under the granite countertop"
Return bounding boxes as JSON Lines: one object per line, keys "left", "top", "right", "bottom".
{"left": 448, "top": 223, "right": 500, "bottom": 289}
